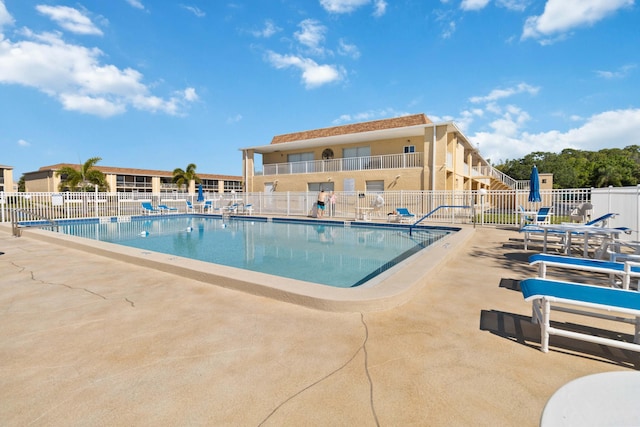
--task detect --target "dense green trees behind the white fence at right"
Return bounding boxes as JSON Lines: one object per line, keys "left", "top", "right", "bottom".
{"left": 495, "top": 145, "right": 640, "bottom": 188}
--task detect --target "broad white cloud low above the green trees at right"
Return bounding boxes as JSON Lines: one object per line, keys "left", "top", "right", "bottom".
{"left": 469, "top": 109, "right": 640, "bottom": 163}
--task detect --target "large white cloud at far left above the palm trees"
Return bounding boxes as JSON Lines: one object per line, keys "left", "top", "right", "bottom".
{"left": 0, "top": 29, "right": 196, "bottom": 117}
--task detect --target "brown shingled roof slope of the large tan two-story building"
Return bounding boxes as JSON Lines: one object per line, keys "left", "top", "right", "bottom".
{"left": 271, "top": 114, "right": 432, "bottom": 144}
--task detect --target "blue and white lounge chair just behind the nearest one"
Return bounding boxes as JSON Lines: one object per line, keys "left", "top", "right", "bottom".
{"left": 529, "top": 254, "right": 640, "bottom": 289}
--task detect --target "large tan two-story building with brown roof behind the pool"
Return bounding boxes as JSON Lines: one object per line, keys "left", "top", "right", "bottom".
{"left": 242, "top": 114, "right": 509, "bottom": 192}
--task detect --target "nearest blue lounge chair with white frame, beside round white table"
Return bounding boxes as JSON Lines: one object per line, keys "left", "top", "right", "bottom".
{"left": 520, "top": 279, "right": 640, "bottom": 353}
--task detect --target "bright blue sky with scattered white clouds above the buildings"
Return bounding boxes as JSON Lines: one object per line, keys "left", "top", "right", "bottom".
{"left": 0, "top": 0, "right": 640, "bottom": 180}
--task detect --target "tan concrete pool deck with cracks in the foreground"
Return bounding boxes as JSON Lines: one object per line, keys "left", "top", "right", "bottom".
{"left": 0, "top": 222, "right": 637, "bottom": 426}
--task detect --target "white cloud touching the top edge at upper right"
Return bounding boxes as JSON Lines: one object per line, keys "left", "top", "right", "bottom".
{"left": 522, "top": 0, "right": 634, "bottom": 44}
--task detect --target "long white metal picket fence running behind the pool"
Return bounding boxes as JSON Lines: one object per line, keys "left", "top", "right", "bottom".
{"left": 0, "top": 187, "right": 600, "bottom": 229}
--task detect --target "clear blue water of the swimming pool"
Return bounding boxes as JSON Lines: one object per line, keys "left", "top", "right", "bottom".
{"left": 60, "top": 216, "right": 452, "bottom": 288}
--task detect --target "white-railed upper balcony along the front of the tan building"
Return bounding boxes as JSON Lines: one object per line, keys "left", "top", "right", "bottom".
{"left": 256, "top": 153, "right": 423, "bottom": 176}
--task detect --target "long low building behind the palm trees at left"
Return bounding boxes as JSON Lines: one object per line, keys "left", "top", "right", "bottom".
{"left": 24, "top": 163, "right": 242, "bottom": 194}
